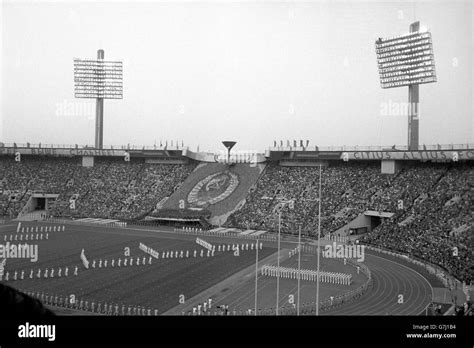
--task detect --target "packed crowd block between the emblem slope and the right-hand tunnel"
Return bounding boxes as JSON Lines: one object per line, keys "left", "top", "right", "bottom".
{"left": 231, "top": 163, "right": 389, "bottom": 235}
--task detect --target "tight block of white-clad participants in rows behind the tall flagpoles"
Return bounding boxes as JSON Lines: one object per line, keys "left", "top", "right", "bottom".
{"left": 260, "top": 265, "right": 352, "bottom": 285}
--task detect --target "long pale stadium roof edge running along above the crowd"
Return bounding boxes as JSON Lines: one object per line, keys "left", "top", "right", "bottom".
{"left": 0, "top": 143, "right": 474, "bottom": 163}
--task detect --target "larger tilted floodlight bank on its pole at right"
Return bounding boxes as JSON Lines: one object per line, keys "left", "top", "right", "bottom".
{"left": 375, "top": 22, "right": 436, "bottom": 150}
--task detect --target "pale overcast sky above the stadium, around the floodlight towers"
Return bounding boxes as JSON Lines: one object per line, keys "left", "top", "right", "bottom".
{"left": 0, "top": 0, "right": 474, "bottom": 152}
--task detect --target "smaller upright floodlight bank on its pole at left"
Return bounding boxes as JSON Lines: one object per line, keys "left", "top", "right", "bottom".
{"left": 74, "top": 50, "right": 123, "bottom": 149}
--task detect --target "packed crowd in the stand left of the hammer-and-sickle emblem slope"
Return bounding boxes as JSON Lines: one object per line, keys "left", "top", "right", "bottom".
{"left": 0, "top": 156, "right": 193, "bottom": 219}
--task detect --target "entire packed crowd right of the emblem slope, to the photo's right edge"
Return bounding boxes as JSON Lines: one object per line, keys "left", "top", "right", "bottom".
{"left": 228, "top": 162, "right": 474, "bottom": 282}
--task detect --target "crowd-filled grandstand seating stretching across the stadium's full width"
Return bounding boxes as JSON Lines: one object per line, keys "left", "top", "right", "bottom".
{"left": 0, "top": 156, "right": 474, "bottom": 282}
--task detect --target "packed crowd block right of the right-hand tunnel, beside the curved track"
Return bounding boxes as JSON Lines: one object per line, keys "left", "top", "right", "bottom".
{"left": 363, "top": 164, "right": 474, "bottom": 283}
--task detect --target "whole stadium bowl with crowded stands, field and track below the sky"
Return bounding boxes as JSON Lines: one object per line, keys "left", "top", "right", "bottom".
{"left": 0, "top": 144, "right": 474, "bottom": 315}
